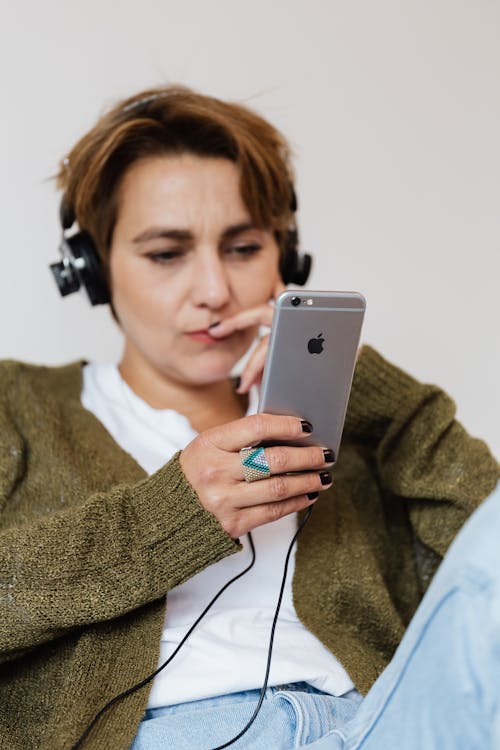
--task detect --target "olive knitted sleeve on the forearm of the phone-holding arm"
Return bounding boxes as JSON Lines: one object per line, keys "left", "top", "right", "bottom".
{"left": 0, "top": 364, "right": 240, "bottom": 661}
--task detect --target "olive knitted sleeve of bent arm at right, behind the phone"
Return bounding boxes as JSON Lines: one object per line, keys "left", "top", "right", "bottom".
{"left": 344, "top": 346, "right": 499, "bottom": 556}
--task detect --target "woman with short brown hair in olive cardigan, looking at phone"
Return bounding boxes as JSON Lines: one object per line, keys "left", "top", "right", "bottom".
{"left": 0, "top": 87, "right": 497, "bottom": 750}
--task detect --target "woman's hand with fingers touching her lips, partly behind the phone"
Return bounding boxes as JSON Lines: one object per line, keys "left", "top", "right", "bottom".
{"left": 210, "top": 282, "right": 286, "bottom": 393}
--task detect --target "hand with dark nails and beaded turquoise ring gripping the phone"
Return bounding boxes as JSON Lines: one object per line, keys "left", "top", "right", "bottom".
{"left": 180, "top": 414, "right": 333, "bottom": 538}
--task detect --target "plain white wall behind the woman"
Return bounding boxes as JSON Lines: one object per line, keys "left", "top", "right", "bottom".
{"left": 0, "top": 0, "right": 500, "bottom": 454}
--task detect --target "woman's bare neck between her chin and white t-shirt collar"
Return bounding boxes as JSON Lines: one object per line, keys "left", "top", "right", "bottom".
{"left": 118, "top": 355, "right": 248, "bottom": 432}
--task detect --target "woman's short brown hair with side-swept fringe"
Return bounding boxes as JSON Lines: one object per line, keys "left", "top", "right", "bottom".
{"left": 56, "top": 86, "right": 295, "bottom": 272}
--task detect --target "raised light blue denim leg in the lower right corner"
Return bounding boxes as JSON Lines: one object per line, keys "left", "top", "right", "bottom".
{"left": 307, "top": 486, "right": 500, "bottom": 750}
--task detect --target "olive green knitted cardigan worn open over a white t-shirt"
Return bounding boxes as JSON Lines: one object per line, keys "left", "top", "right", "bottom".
{"left": 0, "top": 347, "right": 498, "bottom": 750}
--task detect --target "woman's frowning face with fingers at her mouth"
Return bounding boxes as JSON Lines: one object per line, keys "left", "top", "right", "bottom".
{"left": 110, "top": 154, "right": 281, "bottom": 385}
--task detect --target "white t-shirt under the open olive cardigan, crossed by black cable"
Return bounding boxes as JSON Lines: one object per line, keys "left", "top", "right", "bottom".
{"left": 81, "top": 364, "right": 354, "bottom": 708}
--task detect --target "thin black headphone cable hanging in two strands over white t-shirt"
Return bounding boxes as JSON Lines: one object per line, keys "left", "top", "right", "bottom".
{"left": 71, "top": 506, "right": 314, "bottom": 750}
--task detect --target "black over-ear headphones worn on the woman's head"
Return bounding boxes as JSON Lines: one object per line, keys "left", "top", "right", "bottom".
{"left": 50, "top": 191, "right": 312, "bottom": 305}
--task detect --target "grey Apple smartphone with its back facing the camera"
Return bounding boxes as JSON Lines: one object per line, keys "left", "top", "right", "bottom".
{"left": 258, "top": 290, "right": 366, "bottom": 457}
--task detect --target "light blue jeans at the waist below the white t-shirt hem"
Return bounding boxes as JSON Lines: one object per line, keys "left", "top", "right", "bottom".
{"left": 130, "top": 683, "right": 361, "bottom": 750}
